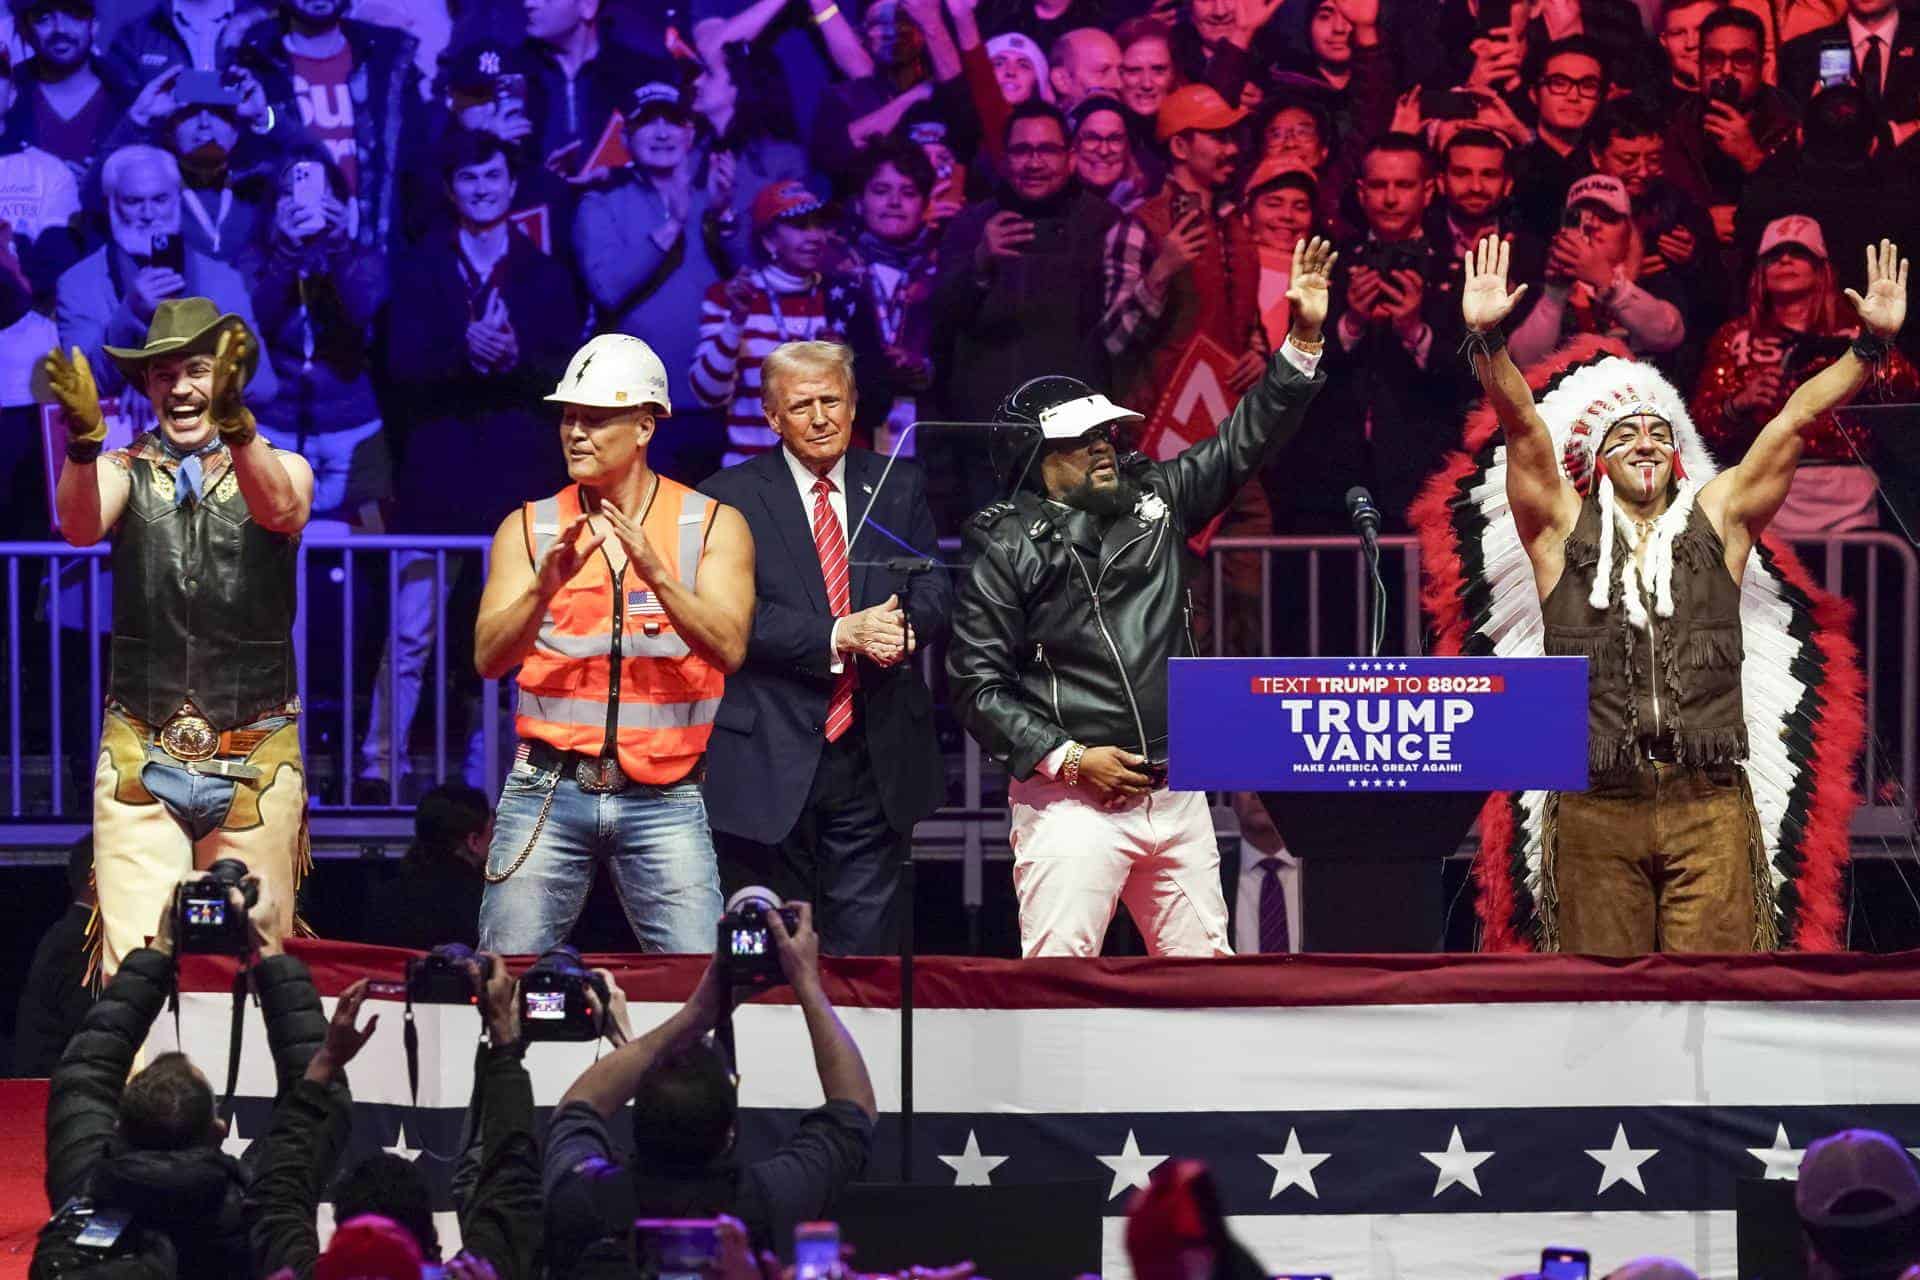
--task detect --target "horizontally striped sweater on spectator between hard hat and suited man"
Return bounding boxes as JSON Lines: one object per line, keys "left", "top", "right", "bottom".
{"left": 687, "top": 267, "right": 839, "bottom": 466}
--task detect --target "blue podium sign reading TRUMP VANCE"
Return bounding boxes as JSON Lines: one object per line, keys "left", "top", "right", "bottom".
{"left": 1167, "top": 658, "right": 1586, "bottom": 791}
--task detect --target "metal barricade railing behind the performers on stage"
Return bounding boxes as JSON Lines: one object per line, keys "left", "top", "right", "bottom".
{"left": 0, "top": 532, "right": 1920, "bottom": 859}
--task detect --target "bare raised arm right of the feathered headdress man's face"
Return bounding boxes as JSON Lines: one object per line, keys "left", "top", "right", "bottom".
{"left": 1699, "top": 240, "right": 1907, "bottom": 537}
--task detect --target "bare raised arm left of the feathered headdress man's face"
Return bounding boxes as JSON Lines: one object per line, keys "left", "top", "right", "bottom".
{"left": 1459, "top": 236, "right": 1580, "bottom": 549}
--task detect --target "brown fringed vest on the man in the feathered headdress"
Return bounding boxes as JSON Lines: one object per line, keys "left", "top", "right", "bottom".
{"left": 1540, "top": 495, "right": 1747, "bottom": 779}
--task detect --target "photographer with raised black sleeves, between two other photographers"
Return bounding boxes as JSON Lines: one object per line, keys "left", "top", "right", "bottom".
{"left": 248, "top": 954, "right": 540, "bottom": 1280}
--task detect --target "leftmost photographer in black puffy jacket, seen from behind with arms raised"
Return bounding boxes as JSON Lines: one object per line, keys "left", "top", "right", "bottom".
{"left": 33, "top": 875, "right": 324, "bottom": 1276}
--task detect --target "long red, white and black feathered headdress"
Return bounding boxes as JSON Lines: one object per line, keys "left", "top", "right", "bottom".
{"left": 1407, "top": 338, "right": 1864, "bottom": 950}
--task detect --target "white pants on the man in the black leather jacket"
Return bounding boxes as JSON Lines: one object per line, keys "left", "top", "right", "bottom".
{"left": 1008, "top": 773, "right": 1233, "bottom": 956}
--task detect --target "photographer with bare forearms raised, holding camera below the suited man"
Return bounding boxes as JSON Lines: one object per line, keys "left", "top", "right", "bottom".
{"left": 545, "top": 904, "right": 876, "bottom": 1276}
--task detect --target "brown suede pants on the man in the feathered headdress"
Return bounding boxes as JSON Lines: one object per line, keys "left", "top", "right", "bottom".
{"left": 1544, "top": 760, "right": 1772, "bottom": 956}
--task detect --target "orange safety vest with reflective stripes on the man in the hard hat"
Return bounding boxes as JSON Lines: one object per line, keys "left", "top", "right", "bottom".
{"left": 515, "top": 476, "right": 726, "bottom": 785}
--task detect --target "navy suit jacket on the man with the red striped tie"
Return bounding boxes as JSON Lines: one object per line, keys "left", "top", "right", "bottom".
{"left": 701, "top": 449, "right": 954, "bottom": 844}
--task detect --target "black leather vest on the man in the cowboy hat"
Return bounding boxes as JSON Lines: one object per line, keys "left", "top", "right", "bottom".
{"left": 108, "top": 432, "right": 300, "bottom": 729}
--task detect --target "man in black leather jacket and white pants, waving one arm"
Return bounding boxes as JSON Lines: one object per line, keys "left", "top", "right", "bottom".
{"left": 947, "top": 235, "right": 1334, "bottom": 956}
